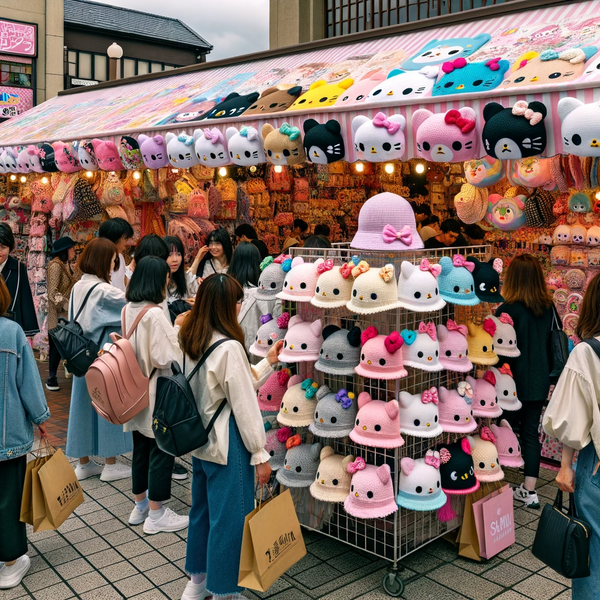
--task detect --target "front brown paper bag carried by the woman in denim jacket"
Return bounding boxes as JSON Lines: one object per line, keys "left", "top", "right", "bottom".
{"left": 38, "top": 448, "right": 83, "bottom": 529}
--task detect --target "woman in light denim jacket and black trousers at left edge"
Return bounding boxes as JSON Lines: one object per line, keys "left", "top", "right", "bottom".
{"left": 0, "top": 278, "right": 50, "bottom": 589}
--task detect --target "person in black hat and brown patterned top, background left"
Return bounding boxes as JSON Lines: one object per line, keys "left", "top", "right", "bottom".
{"left": 46, "top": 237, "right": 80, "bottom": 392}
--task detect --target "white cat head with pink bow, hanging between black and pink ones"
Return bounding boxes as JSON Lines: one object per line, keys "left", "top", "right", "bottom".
{"left": 352, "top": 112, "right": 406, "bottom": 162}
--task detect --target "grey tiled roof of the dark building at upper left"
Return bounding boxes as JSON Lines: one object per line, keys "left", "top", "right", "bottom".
{"left": 64, "top": 0, "right": 213, "bottom": 51}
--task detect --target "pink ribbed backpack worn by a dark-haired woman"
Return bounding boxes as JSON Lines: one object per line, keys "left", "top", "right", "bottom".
{"left": 85, "top": 304, "right": 157, "bottom": 425}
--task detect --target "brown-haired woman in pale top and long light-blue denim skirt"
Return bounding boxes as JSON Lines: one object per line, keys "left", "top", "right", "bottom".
{"left": 66, "top": 238, "right": 133, "bottom": 481}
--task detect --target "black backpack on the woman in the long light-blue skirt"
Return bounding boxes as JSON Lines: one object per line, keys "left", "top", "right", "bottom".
{"left": 48, "top": 283, "right": 100, "bottom": 377}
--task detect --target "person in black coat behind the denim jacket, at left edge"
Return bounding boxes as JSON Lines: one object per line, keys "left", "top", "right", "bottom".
{"left": 0, "top": 223, "right": 40, "bottom": 337}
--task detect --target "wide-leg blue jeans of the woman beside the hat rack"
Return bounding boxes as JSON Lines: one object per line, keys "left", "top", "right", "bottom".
{"left": 185, "top": 416, "right": 254, "bottom": 596}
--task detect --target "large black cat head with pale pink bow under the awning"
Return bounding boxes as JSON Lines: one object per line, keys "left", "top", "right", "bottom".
{"left": 482, "top": 100, "right": 548, "bottom": 160}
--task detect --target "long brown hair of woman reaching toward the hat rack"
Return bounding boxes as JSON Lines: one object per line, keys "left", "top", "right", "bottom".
{"left": 179, "top": 273, "right": 244, "bottom": 360}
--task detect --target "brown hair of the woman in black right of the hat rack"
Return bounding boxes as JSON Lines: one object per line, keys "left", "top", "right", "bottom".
{"left": 502, "top": 254, "right": 552, "bottom": 317}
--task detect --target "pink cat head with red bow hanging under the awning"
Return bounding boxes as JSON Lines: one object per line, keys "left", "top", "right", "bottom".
{"left": 412, "top": 107, "right": 479, "bottom": 162}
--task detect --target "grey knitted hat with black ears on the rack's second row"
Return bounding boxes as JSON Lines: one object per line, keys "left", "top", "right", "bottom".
{"left": 315, "top": 325, "right": 361, "bottom": 375}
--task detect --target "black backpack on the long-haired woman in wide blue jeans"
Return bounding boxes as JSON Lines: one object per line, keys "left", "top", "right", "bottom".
{"left": 152, "top": 338, "right": 229, "bottom": 456}
